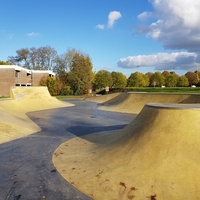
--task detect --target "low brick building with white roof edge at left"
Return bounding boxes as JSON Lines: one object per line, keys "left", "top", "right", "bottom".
{"left": 0, "top": 65, "right": 55, "bottom": 96}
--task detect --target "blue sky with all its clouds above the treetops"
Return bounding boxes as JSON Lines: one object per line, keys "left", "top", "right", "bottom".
{"left": 0, "top": 0, "right": 200, "bottom": 76}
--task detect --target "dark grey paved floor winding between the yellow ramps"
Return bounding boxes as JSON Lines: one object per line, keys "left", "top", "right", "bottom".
{"left": 0, "top": 101, "right": 134, "bottom": 200}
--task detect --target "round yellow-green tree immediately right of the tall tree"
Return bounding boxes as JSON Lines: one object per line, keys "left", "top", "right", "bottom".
{"left": 94, "top": 70, "right": 112, "bottom": 89}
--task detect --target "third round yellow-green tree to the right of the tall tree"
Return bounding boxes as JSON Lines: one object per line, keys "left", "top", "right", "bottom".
{"left": 127, "top": 72, "right": 149, "bottom": 87}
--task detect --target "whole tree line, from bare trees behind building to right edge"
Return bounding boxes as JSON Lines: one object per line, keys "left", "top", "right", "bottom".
{"left": 0, "top": 46, "right": 200, "bottom": 95}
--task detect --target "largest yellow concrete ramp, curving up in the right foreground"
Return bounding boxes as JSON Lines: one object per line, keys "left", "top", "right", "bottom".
{"left": 53, "top": 104, "right": 200, "bottom": 200}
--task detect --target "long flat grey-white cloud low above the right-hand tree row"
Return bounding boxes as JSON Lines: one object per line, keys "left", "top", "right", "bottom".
{"left": 118, "top": 52, "right": 197, "bottom": 70}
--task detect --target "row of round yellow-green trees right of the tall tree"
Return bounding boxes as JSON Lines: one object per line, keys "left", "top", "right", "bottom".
{"left": 94, "top": 70, "right": 200, "bottom": 88}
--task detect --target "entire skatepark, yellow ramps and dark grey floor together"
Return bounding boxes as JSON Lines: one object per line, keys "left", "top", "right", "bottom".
{"left": 0, "top": 87, "right": 200, "bottom": 200}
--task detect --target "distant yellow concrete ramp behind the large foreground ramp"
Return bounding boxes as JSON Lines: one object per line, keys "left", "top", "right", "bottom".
{"left": 91, "top": 93, "right": 200, "bottom": 114}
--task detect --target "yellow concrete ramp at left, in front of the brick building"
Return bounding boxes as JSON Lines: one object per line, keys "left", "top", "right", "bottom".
{"left": 0, "top": 87, "right": 73, "bottom": 144}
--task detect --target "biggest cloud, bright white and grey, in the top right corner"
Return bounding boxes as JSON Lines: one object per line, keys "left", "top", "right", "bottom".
{"left": 138, "top": 0, "right": 200, "bottom": 51}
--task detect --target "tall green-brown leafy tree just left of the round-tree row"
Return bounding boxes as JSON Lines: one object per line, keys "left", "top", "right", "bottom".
{"left": 68, "top": 52, "right": 93, "bottom": 94}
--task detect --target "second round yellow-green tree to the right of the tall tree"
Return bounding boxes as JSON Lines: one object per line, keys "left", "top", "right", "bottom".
{"left": 111, "top": 72, "right": 127, "bottom": 88}
